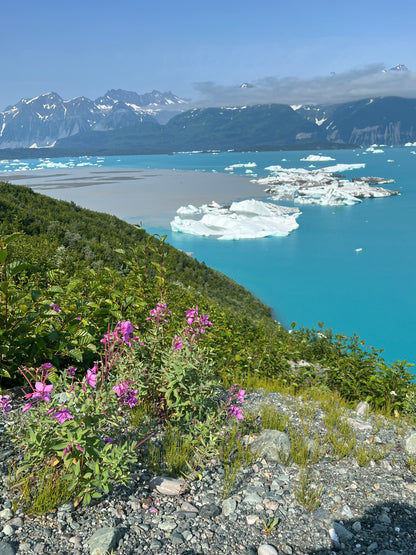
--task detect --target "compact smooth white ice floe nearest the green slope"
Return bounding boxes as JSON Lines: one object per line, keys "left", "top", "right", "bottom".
{"left": 170, "top": 199, "right": 301, "bottom": 240}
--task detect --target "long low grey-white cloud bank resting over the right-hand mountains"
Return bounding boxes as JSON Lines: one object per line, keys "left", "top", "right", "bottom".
{"left": 193, "top": 64, "right": 416, "bottom": 107}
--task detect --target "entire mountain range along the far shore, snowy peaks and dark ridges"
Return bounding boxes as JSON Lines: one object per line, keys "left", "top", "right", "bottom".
{"left": 0, "top": 89, "right": 416, "bottom": 156}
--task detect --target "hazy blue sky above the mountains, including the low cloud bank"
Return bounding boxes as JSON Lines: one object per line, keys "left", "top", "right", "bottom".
{"left": 0, "top": 0, "right": 416, "bottom": 110}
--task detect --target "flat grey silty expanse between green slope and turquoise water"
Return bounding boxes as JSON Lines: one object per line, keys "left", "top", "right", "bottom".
{"left": 0, "top": 167, "right": 265, "bottom": 228}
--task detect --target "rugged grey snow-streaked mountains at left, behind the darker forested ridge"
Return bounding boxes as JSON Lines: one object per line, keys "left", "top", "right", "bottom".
{"left": 0, "top": 89, "right": 186, "bottom": 148}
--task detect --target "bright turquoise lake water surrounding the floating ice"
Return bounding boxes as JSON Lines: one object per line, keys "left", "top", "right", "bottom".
{"left": 0, "top": 147, "right": 416, "bottom": 362}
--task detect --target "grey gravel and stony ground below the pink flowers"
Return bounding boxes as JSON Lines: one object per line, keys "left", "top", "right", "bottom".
{"left": 0, "top": 392, "right": 416, "bottom": 555}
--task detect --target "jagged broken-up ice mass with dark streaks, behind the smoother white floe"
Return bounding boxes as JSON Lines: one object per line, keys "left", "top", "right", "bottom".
{"left": 252, "top": 164, "right": 400, "bottom": 206}
